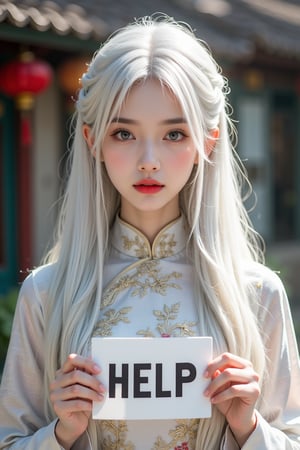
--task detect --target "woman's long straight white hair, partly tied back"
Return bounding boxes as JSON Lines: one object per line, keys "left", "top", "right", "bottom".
{"left": 45, "top": 16, "right": 265, "bottom": 450}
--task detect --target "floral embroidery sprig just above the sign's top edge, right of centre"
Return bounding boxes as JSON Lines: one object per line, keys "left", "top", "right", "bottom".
{"left": 137, "top": 303, "right": 197, "bottom": 337}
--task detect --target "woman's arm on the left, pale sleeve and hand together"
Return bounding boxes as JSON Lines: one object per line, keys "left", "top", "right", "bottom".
{"left": 0, "top": 267, "right": 103, "bottom": 450}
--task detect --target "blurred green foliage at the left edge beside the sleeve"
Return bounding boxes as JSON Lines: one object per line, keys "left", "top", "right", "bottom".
{"left": 0, "top": 289, "right": 18, "bottom": 371}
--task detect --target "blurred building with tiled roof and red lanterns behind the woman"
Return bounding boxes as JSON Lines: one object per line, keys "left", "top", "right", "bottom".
{"left": 0, "top": 0, "right": 300, "bottom": 328}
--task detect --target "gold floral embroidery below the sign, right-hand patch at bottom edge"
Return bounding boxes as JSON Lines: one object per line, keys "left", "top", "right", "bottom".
{"left": 151, "top": 419, "right": 199, "bottom": 450}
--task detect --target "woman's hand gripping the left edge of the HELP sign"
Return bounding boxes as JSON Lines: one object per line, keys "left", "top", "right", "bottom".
{"left": 50, "top": 354, "right": 105, "bottom": 449}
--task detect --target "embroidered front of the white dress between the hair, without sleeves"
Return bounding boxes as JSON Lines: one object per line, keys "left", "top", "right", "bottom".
{"left": 94, "top": 218, "right": 199, "bottom": 450}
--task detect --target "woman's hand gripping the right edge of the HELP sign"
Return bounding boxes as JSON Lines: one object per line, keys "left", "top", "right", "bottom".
{"left": 204, "top": 353, "right": 260, "bottom": 447}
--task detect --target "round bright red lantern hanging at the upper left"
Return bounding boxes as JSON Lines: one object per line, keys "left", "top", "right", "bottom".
{"left": 0, "top": 52, "right": 52, "bottom": 110}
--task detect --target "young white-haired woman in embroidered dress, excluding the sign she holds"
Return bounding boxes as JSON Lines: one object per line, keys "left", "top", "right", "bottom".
{"left": 0, "top": 17, "right": 300, "bottom": 450}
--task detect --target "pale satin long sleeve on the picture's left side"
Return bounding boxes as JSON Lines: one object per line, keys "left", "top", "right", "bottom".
{"left": 0, "top": 268, "right": 61, "bottom": 450}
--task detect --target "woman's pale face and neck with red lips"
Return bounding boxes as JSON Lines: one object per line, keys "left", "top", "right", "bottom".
{"left": 101, "top": 79, "right": 197, "bottom": 226}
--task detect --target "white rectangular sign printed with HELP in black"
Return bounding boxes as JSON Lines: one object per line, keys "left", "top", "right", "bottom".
{"left": 92, "top": 337, "right": 212, "bottom": 420}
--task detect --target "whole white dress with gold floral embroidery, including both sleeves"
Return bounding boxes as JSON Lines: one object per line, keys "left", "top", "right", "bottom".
{"left": 0, "top": 218, "right": 300, "bottom": 450}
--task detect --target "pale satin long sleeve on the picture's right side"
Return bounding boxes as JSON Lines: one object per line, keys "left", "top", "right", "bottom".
{"left": 222, "top": 271, "right": 300, "bottom": 450}
